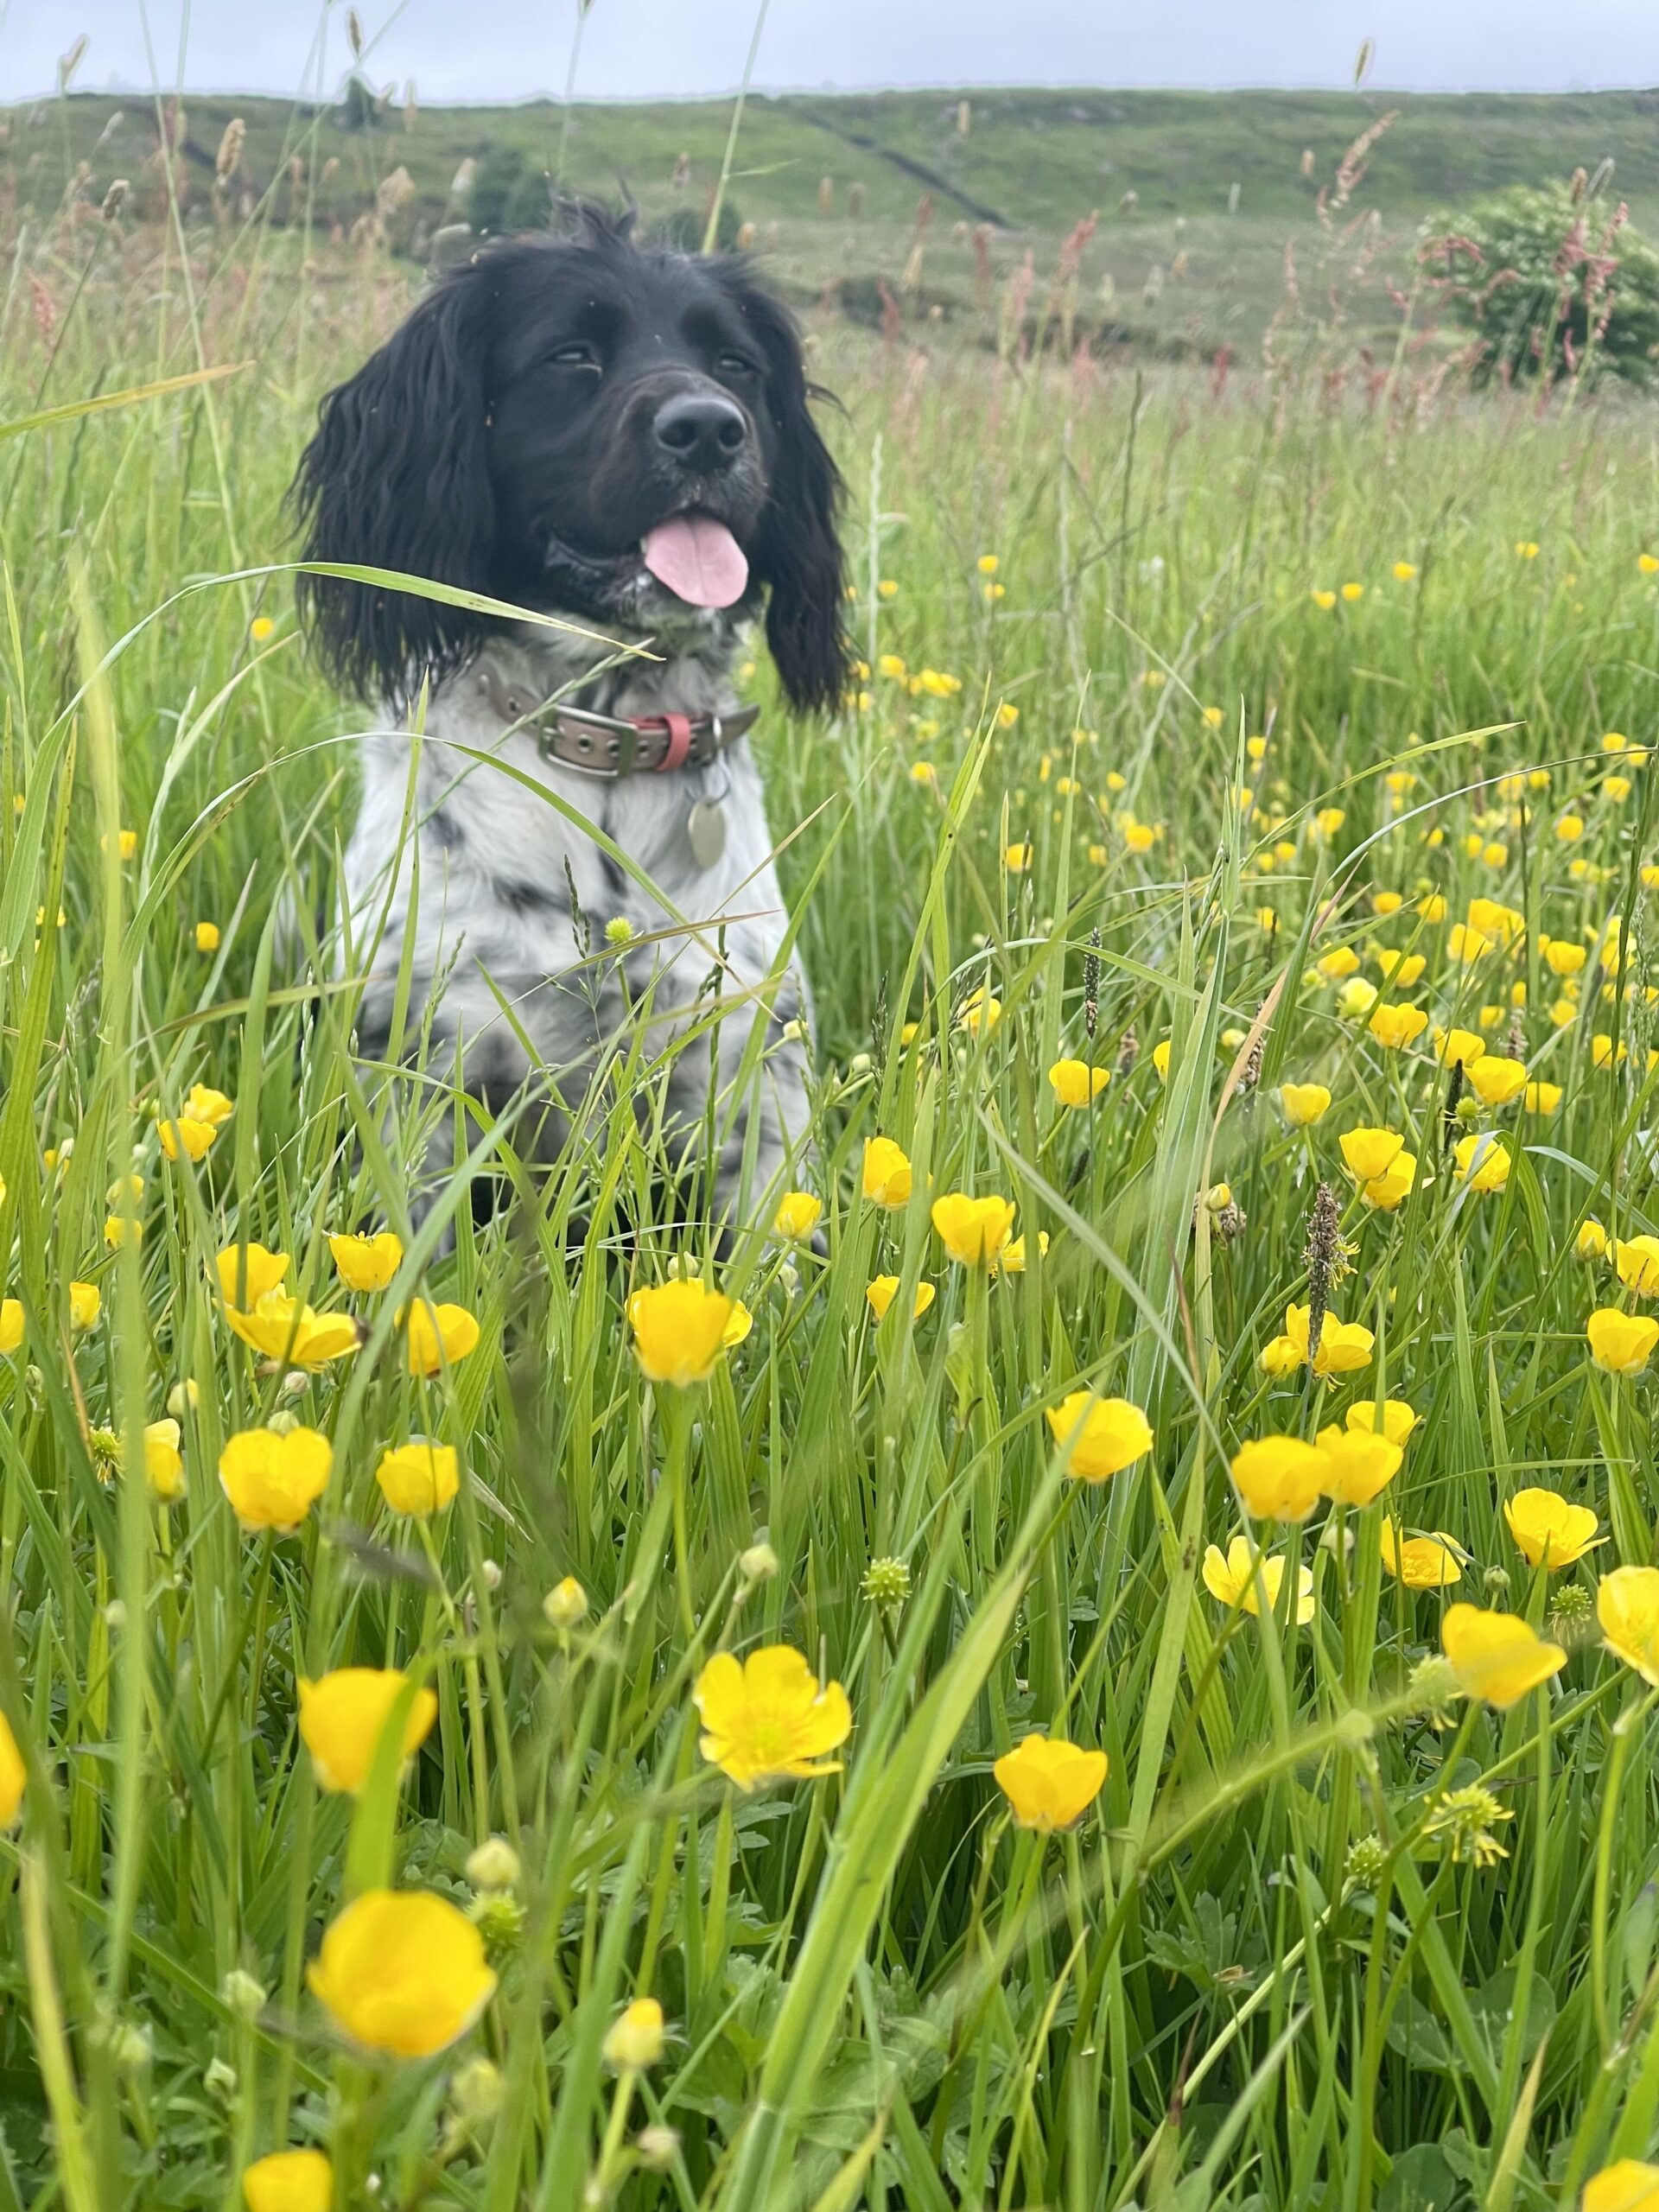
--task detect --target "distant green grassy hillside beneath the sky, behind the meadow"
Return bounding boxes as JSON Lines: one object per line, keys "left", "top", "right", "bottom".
{"left": 0, "top": 91, "right": 1659, "bottom": 349}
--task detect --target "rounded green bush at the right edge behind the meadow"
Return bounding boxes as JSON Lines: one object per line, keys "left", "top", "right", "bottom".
{"left": 1418, "top": 183, "right": 1659, "bottom": 385}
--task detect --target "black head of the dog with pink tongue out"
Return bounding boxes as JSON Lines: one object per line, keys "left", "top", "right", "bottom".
{"left": 294, "top": 208, "right": 847, "bottom": 708}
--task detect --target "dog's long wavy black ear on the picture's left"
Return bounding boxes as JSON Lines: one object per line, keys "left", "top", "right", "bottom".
{"left": 289, "top": 268, "right": 495, "bottom": 699}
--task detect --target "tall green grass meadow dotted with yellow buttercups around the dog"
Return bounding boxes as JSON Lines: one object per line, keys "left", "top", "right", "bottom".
{"left": 0, "top": 104, "right": 1659, "bottom": 2212}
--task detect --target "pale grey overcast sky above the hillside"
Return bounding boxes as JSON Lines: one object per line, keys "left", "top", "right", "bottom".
{"left": 0, "top": 0, "right": 1659, "bottom": 99}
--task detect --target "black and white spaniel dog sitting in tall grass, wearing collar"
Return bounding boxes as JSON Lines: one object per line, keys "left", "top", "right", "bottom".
{"left": 294, "top": 204, "right": 849, "bottom": 1225}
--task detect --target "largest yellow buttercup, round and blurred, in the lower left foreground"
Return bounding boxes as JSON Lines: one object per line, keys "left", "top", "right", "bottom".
{"left": 305, "top": 1889, "right": 495, "bottom": 2059}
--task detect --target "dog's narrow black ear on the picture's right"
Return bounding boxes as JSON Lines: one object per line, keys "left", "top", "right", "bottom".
{"left": 736, "top": 274, "right": 849, "bottom": 708}
